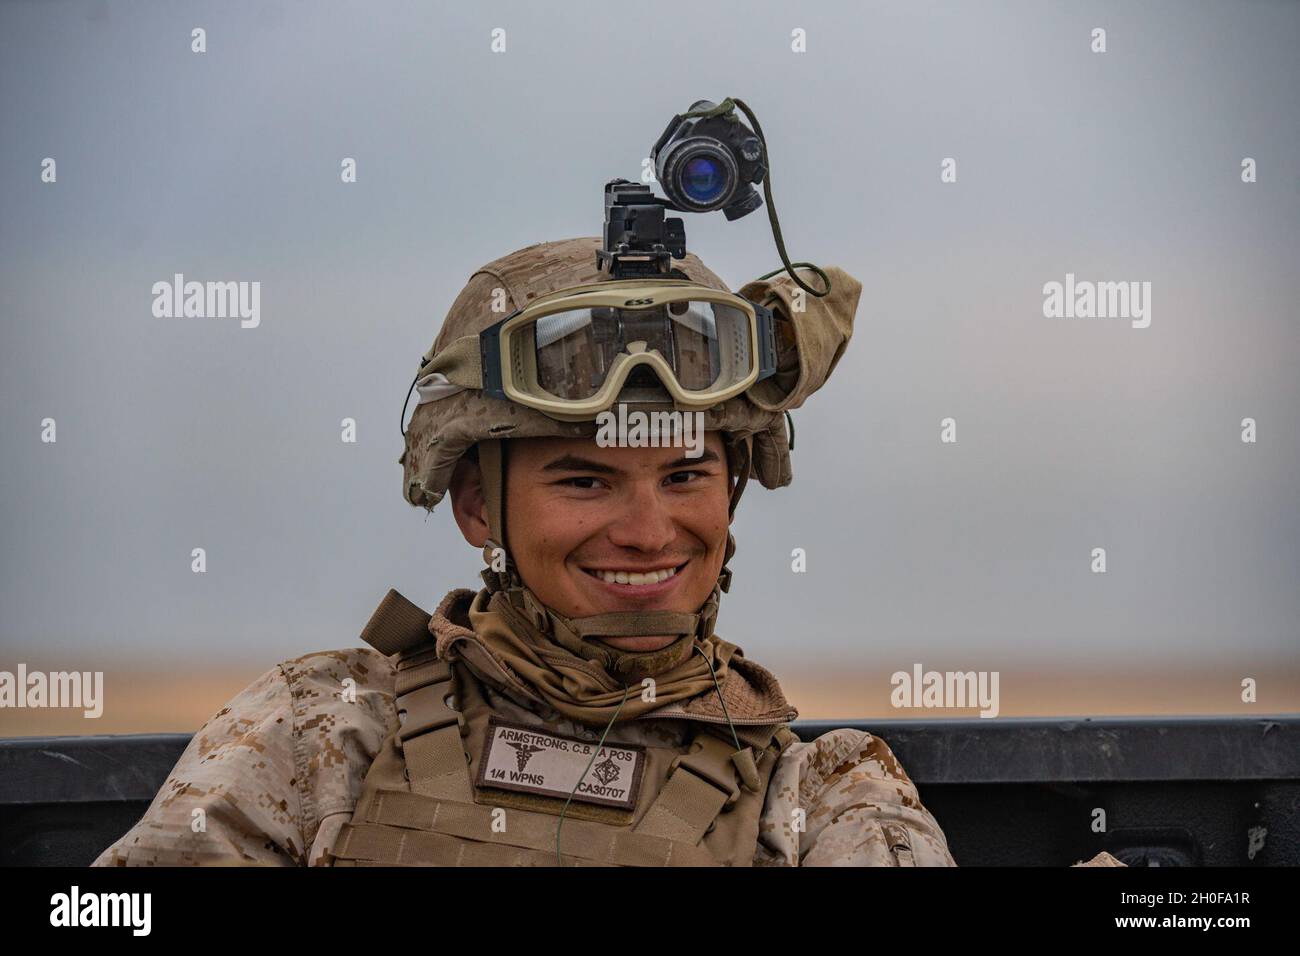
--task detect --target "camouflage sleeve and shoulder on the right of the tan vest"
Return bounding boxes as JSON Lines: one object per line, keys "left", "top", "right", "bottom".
{"left": 754, "top": 730, "right": 957, "bottom": 866}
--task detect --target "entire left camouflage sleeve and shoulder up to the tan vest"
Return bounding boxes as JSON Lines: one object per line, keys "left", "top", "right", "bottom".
{"left": 94, "top": 648, "right": 398, "bottom": 866}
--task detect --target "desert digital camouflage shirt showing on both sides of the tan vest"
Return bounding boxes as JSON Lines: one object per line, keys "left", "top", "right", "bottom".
{"left": 95, "top": 598, "right": 954, "bottom": 866}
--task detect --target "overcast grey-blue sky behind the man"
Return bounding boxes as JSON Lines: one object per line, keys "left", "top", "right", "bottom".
{"left": 0, "top": 0, "right": 1300, "bottom": 686}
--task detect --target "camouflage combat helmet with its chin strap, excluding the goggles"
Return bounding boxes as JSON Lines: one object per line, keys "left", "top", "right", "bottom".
{"left": 399, "top": 237, "right": 861, "bottom": 675}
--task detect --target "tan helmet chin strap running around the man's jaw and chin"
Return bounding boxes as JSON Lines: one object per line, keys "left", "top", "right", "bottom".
{"left": 478, "top": 436, "right": 753, "bottom": 683}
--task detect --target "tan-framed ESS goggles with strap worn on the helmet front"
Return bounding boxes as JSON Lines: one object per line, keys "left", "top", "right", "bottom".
{"left": 421, "top": 280, "right": 776, "bottom": 421}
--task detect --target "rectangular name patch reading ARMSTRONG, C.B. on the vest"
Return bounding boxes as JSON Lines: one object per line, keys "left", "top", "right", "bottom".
{"left": 478, "top": 717, "right": 646, "bottom": 810}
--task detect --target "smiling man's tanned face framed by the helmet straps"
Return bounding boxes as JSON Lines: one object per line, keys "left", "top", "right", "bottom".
{"left": 506, "top": 432, "right": 729, "bottom": 650}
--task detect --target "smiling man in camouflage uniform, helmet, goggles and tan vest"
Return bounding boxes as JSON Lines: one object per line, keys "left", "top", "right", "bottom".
{"left": 98, "top": 238, "right": 953, "bottom": 866}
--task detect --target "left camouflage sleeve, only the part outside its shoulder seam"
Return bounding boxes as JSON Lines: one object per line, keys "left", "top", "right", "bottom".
{"left": 94, "top": 666, "right": 303, "bottom": 866}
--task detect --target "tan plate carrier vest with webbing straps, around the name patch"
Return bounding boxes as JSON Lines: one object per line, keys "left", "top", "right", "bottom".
{"left": 333, "top": 591, "right": 796, "bottom": 866}
